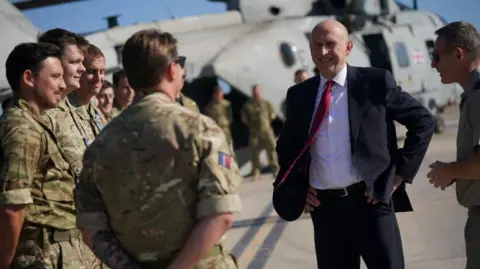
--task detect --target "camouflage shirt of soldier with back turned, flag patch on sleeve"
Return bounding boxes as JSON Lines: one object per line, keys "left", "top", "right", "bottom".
{"left": 75, "top": 93, "right": 242, "bottom": 261}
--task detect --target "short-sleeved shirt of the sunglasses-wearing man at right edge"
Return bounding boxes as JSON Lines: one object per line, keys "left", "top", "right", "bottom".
{"left": 455, "top": 68, "right": 480, "bottom": 207}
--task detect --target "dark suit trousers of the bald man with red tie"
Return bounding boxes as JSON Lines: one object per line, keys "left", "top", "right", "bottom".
{"left": 311, "top": 184, "right": 405, "bottom": 269}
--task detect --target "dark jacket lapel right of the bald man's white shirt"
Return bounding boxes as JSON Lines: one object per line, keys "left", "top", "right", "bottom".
{"left": 347, "top": 65, "right": 367, "bottom": 151}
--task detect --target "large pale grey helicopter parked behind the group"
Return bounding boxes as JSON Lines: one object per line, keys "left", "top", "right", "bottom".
{"left": 0, "top": 0, "right": 461, "bottom": 147}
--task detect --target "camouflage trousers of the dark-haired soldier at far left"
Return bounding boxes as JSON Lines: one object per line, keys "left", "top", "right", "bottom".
{"left": 11, "top": 238, "right": 107, "bottom": 269}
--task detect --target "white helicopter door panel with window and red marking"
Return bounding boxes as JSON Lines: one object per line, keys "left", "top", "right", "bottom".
{"left": 383, "top": 27, "right": 422, "bottom": 93}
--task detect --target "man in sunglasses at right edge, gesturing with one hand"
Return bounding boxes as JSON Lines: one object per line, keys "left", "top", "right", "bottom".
{"left": 427, "top": 21, "right": 480, "bottom": 269}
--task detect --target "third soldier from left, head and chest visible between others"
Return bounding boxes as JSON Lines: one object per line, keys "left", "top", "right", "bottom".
{"left": 68, "top": 44, "right": 107, "bottom": 137}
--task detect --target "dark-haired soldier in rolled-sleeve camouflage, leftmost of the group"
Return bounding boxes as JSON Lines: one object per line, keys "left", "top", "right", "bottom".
{"left": 0, "top": 43, "right": 92, "bottom": 269}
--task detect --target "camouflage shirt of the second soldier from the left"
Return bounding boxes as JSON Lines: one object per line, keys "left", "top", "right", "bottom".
{"left": 43, "top": 97, "right": 95, "bottom": 177}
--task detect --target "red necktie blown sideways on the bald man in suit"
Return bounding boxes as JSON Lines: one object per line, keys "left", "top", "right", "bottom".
{"left": 276, "top": 80, "right": 333, "bottom": 188}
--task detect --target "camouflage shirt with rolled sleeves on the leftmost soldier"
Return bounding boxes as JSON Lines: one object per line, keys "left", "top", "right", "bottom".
{"left": 0, "top": 99, "right": 75, "bottom": 229}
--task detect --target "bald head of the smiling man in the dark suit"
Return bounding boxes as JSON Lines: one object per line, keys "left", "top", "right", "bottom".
{"left": 310, "top": 19, "right": 353, "bottom": 79}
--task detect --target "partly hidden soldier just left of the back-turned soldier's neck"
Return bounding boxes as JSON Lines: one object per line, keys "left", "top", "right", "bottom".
{"left": 111, "top": 69, "right": 135, "bottom": 118}
